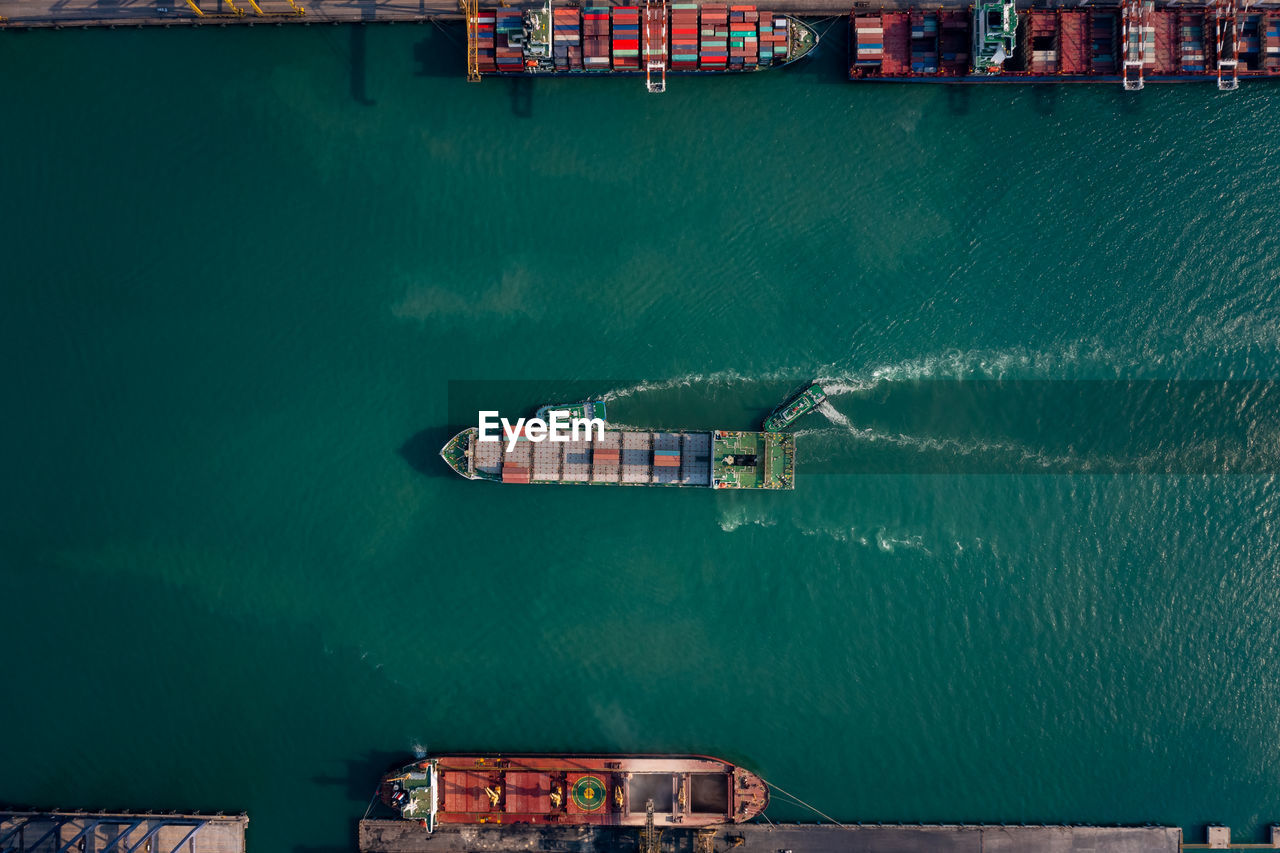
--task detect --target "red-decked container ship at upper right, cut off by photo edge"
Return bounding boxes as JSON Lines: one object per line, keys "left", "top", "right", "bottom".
{"left": 849, "top": 0, "right": 1280, "bottom": 90}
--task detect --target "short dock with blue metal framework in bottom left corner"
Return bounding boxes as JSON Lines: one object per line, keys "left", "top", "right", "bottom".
{"left": 0, "top": 811, "right": 248, "bottom": 853}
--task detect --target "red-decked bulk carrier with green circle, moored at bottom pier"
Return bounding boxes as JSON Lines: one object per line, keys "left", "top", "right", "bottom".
{"left": 379, "top": 754, "right": 769, "bottom": 830}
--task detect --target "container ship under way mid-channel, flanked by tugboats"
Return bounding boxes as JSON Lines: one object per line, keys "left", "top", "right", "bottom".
{"left": 440, "top": 414, "right": 796, "bottom": 489}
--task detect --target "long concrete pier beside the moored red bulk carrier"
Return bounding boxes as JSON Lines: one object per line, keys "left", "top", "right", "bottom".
{"left": 360, "top": 820, "right": 1181, "bottom": 853}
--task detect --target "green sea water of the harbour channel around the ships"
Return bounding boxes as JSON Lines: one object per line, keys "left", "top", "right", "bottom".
{"left": 0, "top": 26, "right": 1280, "bottom": 853}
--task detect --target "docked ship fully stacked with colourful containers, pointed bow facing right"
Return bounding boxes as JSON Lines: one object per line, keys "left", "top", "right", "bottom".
{"left": 467, "top": 0, "right": 818, "bottom": 92}
